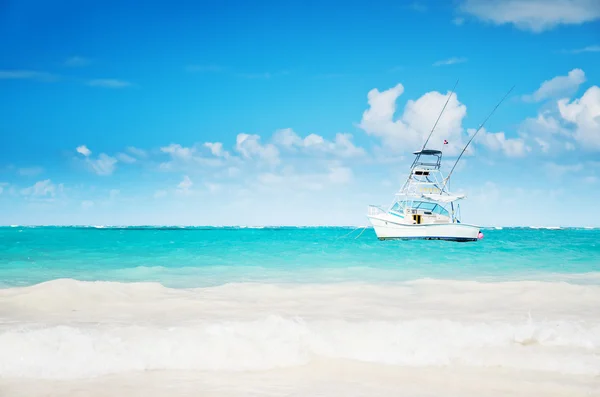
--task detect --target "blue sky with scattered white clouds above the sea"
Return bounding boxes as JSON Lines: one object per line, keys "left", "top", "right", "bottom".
{"left": 0, "top": 0, "right": 600, "bottom": 226}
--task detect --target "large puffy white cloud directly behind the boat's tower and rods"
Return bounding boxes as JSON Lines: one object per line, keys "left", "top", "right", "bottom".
{"left": 359, "top": 84, "right": 467, "bottom": 154}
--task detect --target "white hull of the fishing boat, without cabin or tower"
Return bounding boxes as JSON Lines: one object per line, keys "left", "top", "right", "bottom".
{"left": 369, "top": 216, "right": 481, "bottom": 241}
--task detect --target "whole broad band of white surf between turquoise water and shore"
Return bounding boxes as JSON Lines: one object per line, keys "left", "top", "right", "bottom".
{"left": 0, "top": 280, "right": 600, "bottom": 379}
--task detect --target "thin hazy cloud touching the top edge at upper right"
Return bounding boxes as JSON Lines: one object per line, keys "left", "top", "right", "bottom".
{"left": 460, "top": 0, "right": 600, "bottom": 33}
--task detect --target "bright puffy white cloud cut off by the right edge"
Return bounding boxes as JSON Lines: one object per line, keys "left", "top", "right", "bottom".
{"left": 558, "top": 86, "right": 600, "bottom": 150}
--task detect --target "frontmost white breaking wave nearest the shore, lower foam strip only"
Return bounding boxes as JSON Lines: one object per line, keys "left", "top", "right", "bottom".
{"left": 0, "top": 316, "right": 600, "bottom": 379}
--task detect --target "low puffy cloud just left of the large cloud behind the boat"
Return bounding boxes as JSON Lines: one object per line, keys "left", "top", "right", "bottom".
{"left": 273, "top": 128, "right": 365, "bottom": 157}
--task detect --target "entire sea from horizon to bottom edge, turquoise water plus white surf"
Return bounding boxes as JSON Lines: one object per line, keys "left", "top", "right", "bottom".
{"left": 0, "top": 227, "right": 600, "bottom": 396}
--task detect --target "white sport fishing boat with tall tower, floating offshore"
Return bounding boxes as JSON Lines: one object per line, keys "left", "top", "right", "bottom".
{"left": 367, "top": 149, "right": 482, "bottom": 241}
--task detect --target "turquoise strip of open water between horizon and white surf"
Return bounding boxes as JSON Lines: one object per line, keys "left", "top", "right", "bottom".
{"left": 0, "top": 227, "right": 600, "bottom": 287}
